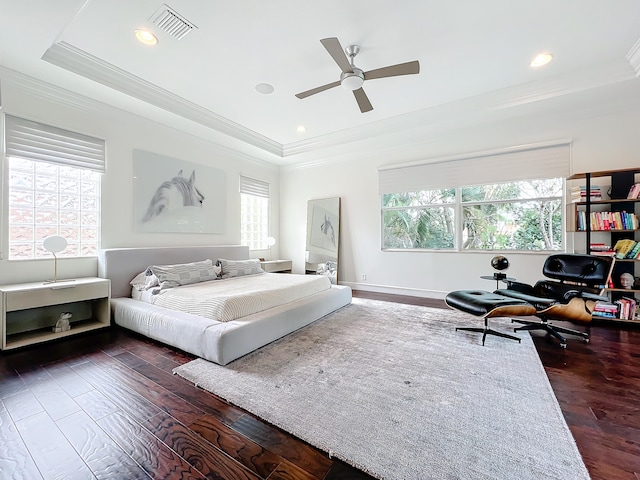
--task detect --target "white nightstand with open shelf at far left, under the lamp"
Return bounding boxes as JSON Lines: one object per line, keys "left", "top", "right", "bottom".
{"left": 0, "top": 278, "right": 111, "bottom": 350}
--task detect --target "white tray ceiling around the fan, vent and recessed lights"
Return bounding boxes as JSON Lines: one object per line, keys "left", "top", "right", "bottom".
{"left": 0, "top": 0, "right": 640, "bottom": 164}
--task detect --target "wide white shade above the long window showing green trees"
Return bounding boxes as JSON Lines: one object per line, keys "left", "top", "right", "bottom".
{"left": 378, "top": 141, "right": 571, "bottom": 194}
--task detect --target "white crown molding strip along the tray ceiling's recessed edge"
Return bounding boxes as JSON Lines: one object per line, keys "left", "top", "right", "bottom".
{"left": 33, "top": 40, "right": 640, "bottom": 160}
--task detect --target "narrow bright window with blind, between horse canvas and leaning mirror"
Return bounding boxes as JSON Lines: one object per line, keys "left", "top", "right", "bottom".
{"left": 240, "top": 175, "right": 269, "bottom": 250}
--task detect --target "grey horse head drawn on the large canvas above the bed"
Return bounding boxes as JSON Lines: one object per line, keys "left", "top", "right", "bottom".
{"left": 142, "top": 169, "right": 204, "bottom": 222}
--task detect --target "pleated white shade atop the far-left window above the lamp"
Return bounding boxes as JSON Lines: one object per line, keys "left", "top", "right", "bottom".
{"left": 5, "top": 115, "right": 105, "bottom": 172}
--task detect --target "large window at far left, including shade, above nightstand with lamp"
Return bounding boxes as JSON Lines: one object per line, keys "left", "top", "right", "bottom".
{"left": 5, "top": 115, "right": 105, "bottom": 260}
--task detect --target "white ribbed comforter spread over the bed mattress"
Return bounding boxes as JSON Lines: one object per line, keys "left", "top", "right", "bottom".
{"left": 137, "top": 273, "right": 331, "bottom": 322}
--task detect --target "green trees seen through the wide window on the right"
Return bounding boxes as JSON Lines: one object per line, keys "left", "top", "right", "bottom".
{"left": 382, "top": 178, "right": 563, "bottom": 251}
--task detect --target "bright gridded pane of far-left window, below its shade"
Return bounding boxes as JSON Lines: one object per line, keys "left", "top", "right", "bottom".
{"left": 7, "top": 157, "right": 101, "bottom": 260}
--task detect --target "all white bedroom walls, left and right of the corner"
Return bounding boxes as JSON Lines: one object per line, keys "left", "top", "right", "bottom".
{"left": 0, "top": 71, "right": 640, "bottom": 297}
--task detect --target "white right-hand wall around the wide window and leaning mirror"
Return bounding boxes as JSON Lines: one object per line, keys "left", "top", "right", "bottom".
{"left": 280, "top": 81, "right": 640, "bottom": 298}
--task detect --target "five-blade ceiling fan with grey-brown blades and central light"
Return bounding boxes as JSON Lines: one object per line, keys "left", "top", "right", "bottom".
{"left": 296, "top": 37, "right": 420, "bottom": 113}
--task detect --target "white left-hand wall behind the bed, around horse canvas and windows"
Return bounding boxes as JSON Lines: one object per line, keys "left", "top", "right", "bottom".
{"left": 0, "top": 71, "right": 280, "bottom": 283}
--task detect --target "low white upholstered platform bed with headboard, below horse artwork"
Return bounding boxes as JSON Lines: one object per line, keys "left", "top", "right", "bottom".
{"left": 98, "top": 245, "right": 351, "bottom": 365}
